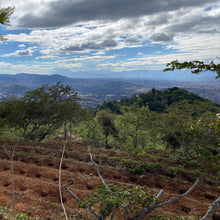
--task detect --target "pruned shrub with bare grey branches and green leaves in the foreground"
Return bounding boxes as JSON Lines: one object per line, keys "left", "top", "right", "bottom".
{"left": 61, "top": 147, "right": 201, "bottom": 220}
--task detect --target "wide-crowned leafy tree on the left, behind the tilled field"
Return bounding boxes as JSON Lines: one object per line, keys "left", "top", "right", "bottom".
{"left": 0, "top": 82, "right": 79, "bottom": 142}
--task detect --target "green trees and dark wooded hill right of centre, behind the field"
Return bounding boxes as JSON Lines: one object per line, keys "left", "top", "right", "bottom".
{"left": 78, "top": 88, "right": 220, "bottom": 161}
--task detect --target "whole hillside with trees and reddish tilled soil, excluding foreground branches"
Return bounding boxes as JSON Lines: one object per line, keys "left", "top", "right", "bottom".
{"left": 0, "top": 81, "right": 220, "bottom": 220}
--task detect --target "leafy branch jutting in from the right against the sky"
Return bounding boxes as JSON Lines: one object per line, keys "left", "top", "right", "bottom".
{"left": 163, "top": 60, "right": 220, "bottom": 79}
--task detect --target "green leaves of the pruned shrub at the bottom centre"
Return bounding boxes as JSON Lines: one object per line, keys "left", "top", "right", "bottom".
{"left": 80, "top": 184, "right": 155, "bottom": 217}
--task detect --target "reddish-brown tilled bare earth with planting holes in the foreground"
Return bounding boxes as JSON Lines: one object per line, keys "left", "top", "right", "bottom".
{"left": 0, "top": 142, "right": 220, "bottom": 220}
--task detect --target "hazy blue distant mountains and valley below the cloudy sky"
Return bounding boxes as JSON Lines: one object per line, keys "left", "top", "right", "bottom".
{"left": 0, "top": 73, "right": 220, "bottom": 107}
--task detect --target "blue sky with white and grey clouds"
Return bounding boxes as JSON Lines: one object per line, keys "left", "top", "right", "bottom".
{"left": 0, "top": 0, "right": 220, "bottom": 78}
